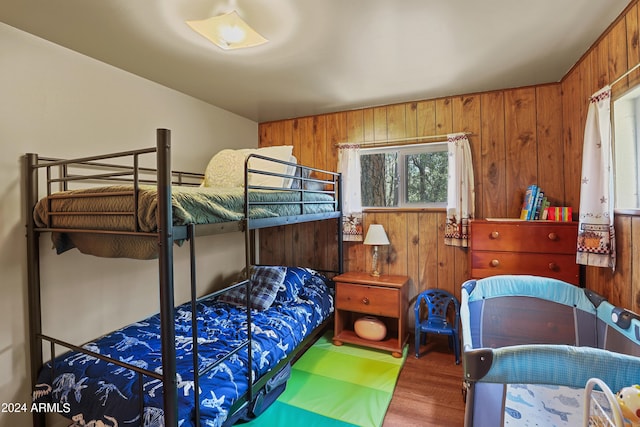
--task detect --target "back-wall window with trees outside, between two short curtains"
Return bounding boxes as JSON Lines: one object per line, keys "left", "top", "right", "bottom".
{"left": 360, "top": 142, "right": 448, "bottom": 208}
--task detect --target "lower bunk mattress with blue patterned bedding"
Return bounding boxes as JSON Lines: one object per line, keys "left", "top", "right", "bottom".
{"left": 34, "top": 267, "right": 333, "bottom": 427}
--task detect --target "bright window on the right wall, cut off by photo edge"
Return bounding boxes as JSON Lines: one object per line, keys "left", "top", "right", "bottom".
{"left": 613, "top": 88, "right": 640, "bottom": 209}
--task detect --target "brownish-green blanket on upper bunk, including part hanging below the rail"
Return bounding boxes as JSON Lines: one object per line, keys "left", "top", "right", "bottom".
{"left": 34, "top": 185, "right": 334, "bottom": 259}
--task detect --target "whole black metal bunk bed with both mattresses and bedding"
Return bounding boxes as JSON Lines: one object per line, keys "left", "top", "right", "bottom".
{"left": 24, "top": 129, "right": 343, "bottom": 427}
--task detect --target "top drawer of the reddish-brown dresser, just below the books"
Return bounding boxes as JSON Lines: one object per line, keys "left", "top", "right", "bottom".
{"left": 471, "top": 221, "right": 578, "bottom": 255}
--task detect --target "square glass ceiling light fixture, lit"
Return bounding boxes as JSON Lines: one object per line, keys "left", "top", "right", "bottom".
{"left": 187, "top": 10, "right": 268, "bottom": 50}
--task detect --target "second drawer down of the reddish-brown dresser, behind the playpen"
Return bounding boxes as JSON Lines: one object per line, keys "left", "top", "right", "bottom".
{"left": 471, "top": 251, "right": 580, "bottom": 284}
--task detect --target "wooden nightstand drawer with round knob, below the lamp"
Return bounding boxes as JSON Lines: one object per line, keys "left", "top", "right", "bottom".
{"left": 336, "top": 283, "right": 400, "bottom": 317}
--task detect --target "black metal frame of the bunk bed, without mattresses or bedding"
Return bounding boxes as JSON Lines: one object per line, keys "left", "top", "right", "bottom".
{"left": 24, "top": 129, "right": 343, "bottom": 427}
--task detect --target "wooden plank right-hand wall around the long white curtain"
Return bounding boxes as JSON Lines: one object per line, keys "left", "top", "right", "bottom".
{"left": 561, "top": 1, "right": 640, "bottom": 312}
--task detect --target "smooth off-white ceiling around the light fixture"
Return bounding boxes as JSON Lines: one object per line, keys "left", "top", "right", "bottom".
{"left": 0, "top": 0, "right": 629, "bottom": 122}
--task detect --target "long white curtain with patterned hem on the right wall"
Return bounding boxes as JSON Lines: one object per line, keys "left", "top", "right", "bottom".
{"left": 576, "top": 86, "right": 616, "bottom": 270}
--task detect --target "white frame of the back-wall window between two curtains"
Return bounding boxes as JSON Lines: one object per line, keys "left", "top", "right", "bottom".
{"left": 360, "top": 139, "right": 448, "bottom": 210}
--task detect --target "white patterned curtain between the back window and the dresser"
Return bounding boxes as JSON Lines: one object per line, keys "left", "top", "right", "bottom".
{"left": 444, "top": 133, "right": 475, "bottom": 247}
